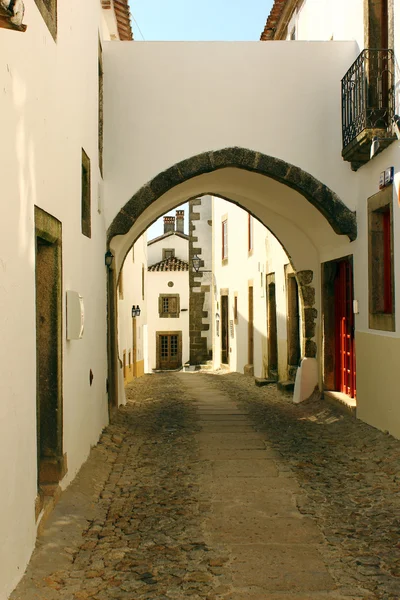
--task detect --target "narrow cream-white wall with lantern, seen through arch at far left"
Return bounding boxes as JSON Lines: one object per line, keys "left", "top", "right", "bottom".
{"left": 117, "top": 234, "right": 147, "bottom": 397}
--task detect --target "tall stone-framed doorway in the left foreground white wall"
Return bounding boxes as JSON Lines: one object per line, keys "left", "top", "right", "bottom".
{"left": 35, "top": 207, "right": 67, "bottom": 510}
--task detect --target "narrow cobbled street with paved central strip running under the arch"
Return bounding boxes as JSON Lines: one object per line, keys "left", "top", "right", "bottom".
{"left": 11, "top": 373, "right": 400, "bottom": 600}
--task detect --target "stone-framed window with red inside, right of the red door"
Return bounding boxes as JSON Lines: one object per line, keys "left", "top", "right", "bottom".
{"left": 368, "top": 186, "right": 395, "bottom": 331}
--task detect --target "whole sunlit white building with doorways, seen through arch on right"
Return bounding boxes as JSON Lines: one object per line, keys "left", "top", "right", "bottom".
{"left": 213, "top": 198, "right": 300, "bottom": 384}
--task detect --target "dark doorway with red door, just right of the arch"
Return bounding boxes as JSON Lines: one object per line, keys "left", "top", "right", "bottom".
{"left": 322, "top": 256, "right": 356, "bottom": 398}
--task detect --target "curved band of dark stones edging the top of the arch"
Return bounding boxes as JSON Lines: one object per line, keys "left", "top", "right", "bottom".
{"left": 107, "top": 147, "right": 357, "bottom": 241}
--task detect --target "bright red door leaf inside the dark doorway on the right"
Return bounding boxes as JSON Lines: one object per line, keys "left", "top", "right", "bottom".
{"left": 335, "top": 260, "right": 356, "bottom": 398}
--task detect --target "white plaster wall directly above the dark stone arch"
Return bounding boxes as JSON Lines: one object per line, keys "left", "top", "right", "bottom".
{"left": 104, "top": 42, "right": 358, "bottom": 224}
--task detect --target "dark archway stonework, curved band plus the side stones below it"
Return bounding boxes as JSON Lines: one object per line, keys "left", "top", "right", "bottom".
{"left": 107, "top": 147, "right": 357, "bottom": 406}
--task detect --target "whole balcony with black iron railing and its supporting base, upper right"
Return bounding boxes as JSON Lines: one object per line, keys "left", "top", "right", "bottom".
{"left": 342, "top": 49, "right": 395, "bottom": 171}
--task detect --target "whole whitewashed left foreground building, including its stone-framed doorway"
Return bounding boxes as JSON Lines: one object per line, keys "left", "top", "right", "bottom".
{"left": 0, "top": 0, "right": 132, "bottom": 599}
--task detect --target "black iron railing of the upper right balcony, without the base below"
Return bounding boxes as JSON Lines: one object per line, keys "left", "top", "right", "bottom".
{"left": 342, "top": 49, "right": 395, "bottom": 148}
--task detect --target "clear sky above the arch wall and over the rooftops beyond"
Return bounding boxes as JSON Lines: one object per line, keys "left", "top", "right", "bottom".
{"left": 129, "top": 0, "right": 273, "bottom": 240}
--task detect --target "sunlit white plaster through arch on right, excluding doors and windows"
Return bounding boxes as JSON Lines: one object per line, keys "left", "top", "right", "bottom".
{"left": 213, "top": 198, "right": 289, "bottom": 380}
